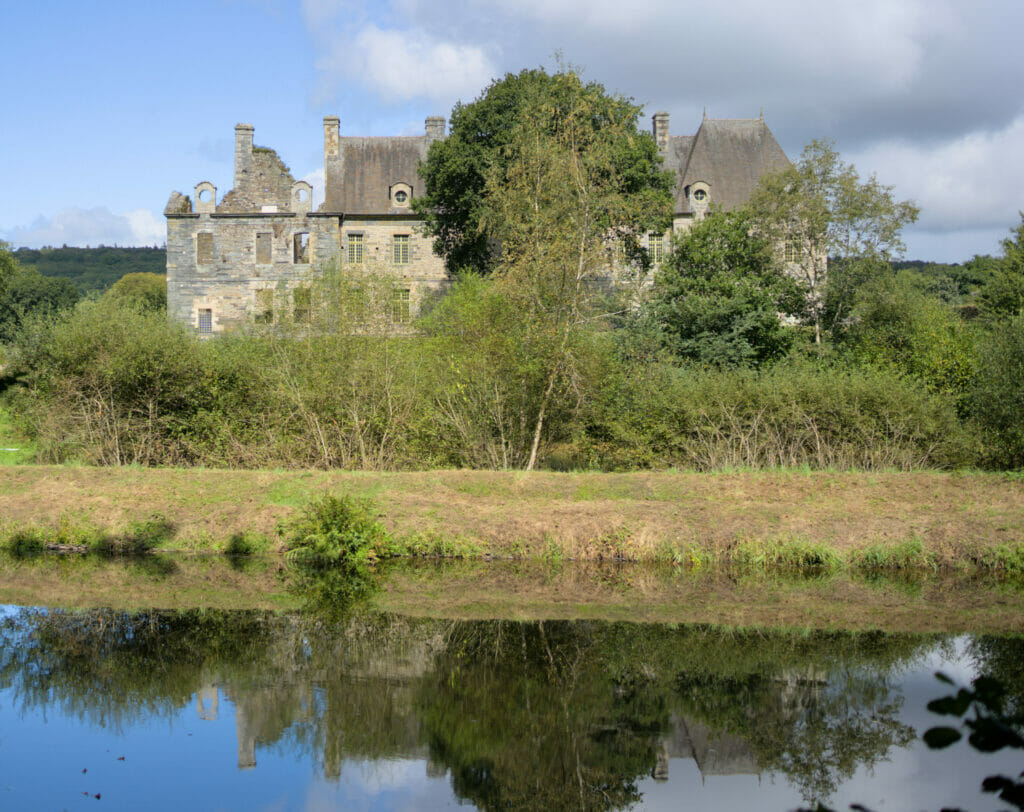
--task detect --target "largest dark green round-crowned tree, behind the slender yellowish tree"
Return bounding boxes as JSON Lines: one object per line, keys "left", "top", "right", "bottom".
{"left": 416, "top": 69, "right": 672, "bottom": 273}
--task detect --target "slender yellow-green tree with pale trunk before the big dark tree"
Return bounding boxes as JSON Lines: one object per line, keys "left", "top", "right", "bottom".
{"left": 479, "top": 70, "right": 671, "bottom": 470}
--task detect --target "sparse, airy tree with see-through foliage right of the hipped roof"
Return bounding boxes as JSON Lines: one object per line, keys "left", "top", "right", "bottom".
{"left": 751, "top": 140, "right": 920, "bottom": 343}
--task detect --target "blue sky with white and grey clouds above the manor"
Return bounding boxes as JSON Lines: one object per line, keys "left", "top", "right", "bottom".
{"left": 0, "top": 0, "right": 1024, "bottom": 262}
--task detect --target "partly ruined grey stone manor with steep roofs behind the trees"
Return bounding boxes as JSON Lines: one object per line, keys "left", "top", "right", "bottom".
{"left": 164, "top": 113, "right": 790, "bottom": 334}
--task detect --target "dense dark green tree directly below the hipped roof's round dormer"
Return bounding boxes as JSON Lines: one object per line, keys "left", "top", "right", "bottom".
{"left": 651, "top": 210, "right": 804, "bottom": 367}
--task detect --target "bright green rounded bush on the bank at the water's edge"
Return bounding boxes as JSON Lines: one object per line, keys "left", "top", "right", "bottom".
{"left": 279, "top": 495, "right": 390, "bottom": 568}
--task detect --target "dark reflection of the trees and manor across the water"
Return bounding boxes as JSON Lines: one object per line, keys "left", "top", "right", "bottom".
{"left": 0, "top": 609, "right": 1024, "bottom": 809}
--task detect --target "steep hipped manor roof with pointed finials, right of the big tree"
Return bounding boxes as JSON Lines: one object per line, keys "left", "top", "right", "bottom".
{"left": 662, "top": 119, "right": 790, "bottom": 213}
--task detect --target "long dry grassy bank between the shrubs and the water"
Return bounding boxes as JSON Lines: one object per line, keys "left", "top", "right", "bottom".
{"left": 0, "top": 466, "right": 1024, "bottom": 571}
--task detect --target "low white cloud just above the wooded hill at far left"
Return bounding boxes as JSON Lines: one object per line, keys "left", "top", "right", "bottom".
{"left": 3, "top": 206, "right": 167, "bottom": 248}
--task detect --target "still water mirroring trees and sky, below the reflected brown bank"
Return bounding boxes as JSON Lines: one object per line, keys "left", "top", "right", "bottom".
{"left": 0, "top": 605, "right": 1024, "bottom": 810}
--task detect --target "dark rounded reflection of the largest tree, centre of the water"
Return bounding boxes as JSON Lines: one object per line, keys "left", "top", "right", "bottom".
{"left": 421, "top": 622, "right": 668, "bottom": 809}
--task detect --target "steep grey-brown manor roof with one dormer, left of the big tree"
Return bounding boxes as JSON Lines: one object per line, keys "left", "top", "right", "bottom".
{"left": 321, "top": 135, "right": 430, "bottom": 214}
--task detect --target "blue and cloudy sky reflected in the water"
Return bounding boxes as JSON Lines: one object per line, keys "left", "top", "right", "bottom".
{"left": 0, "top": 622, "right": 1021, "bottom": 812}
